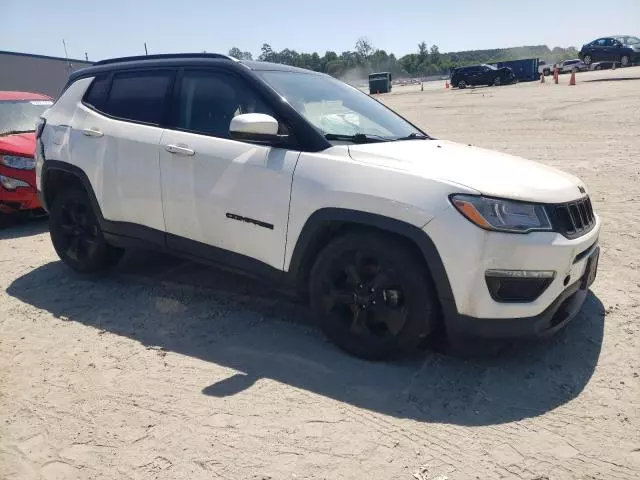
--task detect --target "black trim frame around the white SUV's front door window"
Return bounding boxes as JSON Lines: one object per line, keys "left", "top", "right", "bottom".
{"left": 165, "top": 65, "right": 302, "bottom": 151}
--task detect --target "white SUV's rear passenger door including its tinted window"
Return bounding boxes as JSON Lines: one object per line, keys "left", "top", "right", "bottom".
{"left": 70, "top": 69, "right": 175, "bottom": 231}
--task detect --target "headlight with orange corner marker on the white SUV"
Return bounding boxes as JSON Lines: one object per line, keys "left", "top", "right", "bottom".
{"left": 451, "top": 195, "right": 552, "bottom": 233}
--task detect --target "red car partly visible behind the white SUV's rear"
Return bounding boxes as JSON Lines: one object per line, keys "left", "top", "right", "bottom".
{"left": 0, "top": 92, "right": 53, "bottom": 226}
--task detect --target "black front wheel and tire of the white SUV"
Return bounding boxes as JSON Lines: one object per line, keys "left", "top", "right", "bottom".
{"left": 309, "top": 232, "right": 439, "bottom": 360}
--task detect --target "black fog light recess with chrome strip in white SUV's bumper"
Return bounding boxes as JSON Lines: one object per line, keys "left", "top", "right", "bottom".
{"left": 485, "top": 270, "right": 556, "bottom": 303}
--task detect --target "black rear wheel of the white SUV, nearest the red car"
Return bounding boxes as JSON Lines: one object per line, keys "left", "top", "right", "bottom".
{"left": 49, "top": 188, "right": 124, "bottom": 273}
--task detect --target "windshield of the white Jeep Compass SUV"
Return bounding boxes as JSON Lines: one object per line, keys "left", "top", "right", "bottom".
{"left": 258, "top": 70, "right": 424, "bottom": 143}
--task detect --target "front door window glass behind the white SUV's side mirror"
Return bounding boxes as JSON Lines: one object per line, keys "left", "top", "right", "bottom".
{"left": 175, "top": 70, "right": 275, "bottom": 138}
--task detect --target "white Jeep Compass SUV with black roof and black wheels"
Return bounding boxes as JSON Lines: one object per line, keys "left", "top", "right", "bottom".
{"left": 36, "top": 54, "right": 600, "bottom": 358}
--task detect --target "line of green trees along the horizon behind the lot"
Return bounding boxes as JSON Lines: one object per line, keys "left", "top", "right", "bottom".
{"left": 229, "top": 37, "right": 578, "bottom": 79}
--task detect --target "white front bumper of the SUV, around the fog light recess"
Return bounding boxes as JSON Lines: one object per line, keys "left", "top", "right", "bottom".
{"left": 423, "top": 202, "right": 601, "bottom": 331}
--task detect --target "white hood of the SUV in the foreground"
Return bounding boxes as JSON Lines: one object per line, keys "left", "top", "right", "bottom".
{"left": 349, "top": 140, "right": 585, "bottom": 203}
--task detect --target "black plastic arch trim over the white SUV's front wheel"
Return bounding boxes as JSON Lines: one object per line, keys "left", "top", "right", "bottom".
{"left": 286, "top": 208, "right": 457, "bottom": 318}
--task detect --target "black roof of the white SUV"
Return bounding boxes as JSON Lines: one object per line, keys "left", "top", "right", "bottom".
{"left": 69, "top": 53, "right": 323, "bottom": 82}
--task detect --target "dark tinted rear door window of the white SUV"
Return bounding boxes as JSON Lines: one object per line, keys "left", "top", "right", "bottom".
{"left": 101, "top": 70, "right": 174, "bottom": 125}
